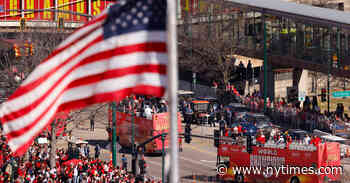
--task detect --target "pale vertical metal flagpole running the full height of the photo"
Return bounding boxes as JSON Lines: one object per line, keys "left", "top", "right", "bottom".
{"left": 167, "top": 0, "right": 179, "bottom": 183}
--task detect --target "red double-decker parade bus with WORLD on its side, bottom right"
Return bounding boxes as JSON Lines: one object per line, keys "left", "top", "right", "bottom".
{"left": 217, "top": 137, "right": 343, "bottom": 183}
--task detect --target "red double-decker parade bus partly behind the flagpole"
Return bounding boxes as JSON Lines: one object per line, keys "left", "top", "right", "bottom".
{"left": 107, "top": 110, "right": 182, "bottom": 153}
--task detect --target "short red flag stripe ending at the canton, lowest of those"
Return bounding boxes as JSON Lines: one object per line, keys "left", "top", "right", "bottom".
{"left": 8, "top": 36, "right": 103, "bottom": 101}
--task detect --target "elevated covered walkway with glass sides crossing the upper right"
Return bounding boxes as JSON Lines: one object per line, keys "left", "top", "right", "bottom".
{"left": 179, "top": 0, "right": 350, "bottom": 101}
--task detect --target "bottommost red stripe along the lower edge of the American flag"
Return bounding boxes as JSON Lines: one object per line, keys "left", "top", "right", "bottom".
{"left": 14, "top": 85, "right": 165, "bottom": 155}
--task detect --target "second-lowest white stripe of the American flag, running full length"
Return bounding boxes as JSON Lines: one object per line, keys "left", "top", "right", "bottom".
{"left": 4, "top": 52, "right": 168, "bottom": 134}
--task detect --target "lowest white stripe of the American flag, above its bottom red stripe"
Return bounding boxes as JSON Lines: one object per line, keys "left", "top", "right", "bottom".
{"left": 8, "top": 73, "right": 167, "bottom": 151}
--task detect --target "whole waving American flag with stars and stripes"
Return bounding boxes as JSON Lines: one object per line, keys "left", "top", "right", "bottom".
{"left": 0, "top": 0, "right": 168, "bottom": 155}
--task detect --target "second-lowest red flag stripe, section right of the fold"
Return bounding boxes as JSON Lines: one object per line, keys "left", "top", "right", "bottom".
{"left": 67, "top": 65, "right": 166, "bottom": 88}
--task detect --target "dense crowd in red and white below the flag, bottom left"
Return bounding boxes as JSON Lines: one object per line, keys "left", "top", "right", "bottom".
{"left": 0, "top": 127, "right": 162, "bottom": 183}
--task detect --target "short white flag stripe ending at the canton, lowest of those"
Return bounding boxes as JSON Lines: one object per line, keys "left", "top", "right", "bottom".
{"left": 22, "top": 29, "right": 103, "bottom": 86}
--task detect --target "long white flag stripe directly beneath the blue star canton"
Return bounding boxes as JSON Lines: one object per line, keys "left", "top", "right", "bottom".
{"left": 2, "top": 31, "right": 166, "bottom": 117}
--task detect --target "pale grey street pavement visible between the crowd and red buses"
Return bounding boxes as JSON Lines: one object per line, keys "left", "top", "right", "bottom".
{"left": 63, "top": 107, "right": 216, "bottom": 182}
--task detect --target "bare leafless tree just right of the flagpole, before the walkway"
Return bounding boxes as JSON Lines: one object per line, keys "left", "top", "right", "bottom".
{"left": 179, "top": 2, "right": 246, "bottom": 84}
